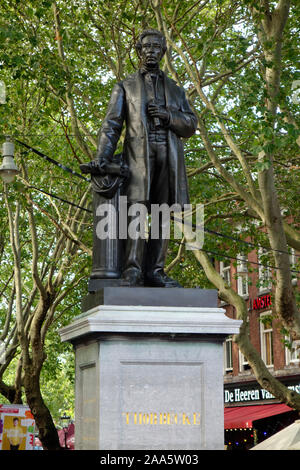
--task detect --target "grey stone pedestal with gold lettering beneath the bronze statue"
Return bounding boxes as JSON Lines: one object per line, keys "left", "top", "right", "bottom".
{"left": 60, "top": 288, "right": 241, "bottom": 450}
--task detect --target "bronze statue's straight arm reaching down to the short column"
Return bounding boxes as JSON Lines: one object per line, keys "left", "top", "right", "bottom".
{"left": 96, "top": 83, "right": 125, "bottom": 162}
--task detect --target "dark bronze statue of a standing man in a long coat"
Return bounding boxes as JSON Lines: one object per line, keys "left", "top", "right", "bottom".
{"left": 96, "top": 29, "right": 197, "bottom": 287}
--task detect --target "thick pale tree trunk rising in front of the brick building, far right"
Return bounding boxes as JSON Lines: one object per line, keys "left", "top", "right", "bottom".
{"left": 253, "top": 0, "right": 300, "bottom": 335}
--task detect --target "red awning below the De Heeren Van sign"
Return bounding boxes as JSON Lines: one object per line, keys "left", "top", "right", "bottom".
{"left": 224, "top": 404, "right": 293, "bottom": 429}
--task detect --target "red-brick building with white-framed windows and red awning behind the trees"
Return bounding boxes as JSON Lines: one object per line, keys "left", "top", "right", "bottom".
{"left": 217, "top": 246, "right": 300, "bottom": 450}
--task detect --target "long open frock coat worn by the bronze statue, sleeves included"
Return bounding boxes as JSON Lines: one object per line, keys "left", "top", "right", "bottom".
{"left": 97, "top": 72, "right": 197, "bottom": 206}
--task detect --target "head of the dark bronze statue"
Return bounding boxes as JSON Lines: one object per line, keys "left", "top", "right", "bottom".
{"left": 136, "top": 29, "right": 167, "bottom": 68}
